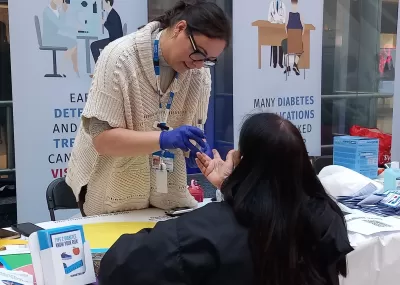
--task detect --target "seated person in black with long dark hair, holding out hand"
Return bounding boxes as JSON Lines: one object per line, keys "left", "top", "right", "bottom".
{"left": 99, "top": 113, "right": 352, "bottom": 285}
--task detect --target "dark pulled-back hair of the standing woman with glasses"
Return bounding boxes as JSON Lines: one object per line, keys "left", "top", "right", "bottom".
{"left": 153, "top": 0, "right": 232, "bottom": 46}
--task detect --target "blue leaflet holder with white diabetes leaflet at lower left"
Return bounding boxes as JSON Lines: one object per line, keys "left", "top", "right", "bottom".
{"left": 38, "top": 226, "right": 86, "bottom": 277}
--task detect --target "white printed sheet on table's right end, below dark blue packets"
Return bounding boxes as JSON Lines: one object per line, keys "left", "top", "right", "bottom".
{"left": 345, "top": 214, "right": 400, "bottom": 236}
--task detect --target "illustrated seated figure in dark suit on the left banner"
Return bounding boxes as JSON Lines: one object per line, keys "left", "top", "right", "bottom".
{"left": 90, "top": 0, "right": 123, "bottom": 62}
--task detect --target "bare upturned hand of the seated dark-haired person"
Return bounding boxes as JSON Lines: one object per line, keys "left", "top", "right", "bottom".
{"left": 196, "top": 149, "right": 240, "bottom": 189}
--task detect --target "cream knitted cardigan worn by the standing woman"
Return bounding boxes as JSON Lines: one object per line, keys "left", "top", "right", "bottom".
{"left": 66, "top": 22, "right": 211, "bottom": 215}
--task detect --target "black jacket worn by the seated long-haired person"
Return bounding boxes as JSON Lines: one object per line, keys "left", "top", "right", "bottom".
{"left": 99, "top": 202, "right": 351, "bottom": 285}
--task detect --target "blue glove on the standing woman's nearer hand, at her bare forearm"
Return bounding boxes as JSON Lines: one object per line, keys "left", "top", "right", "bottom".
{"left": 160, "top": 126, "right": 206, "bottom": 153}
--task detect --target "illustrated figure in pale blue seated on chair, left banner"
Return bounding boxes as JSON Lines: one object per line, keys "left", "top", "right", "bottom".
{"left": 43, "top": 0, "right": 79, "bottom": 77}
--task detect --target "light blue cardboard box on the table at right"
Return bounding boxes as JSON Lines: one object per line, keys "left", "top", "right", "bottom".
{"left": 333, "top": 136, "right": 379, "bottom": 179}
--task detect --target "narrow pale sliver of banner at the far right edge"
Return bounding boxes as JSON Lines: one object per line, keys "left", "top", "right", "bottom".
{"left": 392, "top": 4, "right": 400, "bottom": 161}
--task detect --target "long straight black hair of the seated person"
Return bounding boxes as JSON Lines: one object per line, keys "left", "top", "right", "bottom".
{"left": 221, "top": 113, "right": 351, "bottom": 285}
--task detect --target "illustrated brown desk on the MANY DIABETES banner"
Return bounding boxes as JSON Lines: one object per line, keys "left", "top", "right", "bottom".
{"left": 252, "top": 20, "right": 315, "bottom": 69}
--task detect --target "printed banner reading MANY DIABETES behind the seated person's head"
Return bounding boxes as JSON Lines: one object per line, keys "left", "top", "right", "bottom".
{"left": 233, "top": 0, "right": 323, "bottom": 156}
